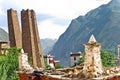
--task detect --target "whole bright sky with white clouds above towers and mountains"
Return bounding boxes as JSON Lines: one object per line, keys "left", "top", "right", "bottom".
{"left": 0, "top": 0, "right": 110, "bottom": 39}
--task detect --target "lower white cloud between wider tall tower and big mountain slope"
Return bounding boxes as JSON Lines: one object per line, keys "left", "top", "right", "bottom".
{"left": 38, "top": 20, "right": 66, "bottom": 39}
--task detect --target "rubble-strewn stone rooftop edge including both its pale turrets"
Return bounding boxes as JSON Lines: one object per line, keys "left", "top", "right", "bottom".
{"left": 19, "top": 35, "right": 120, "bottom": 80}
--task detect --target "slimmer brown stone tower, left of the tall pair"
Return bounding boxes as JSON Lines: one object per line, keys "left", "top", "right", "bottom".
{"left": 7, "top": 9, "right": 22, "bottom": 48}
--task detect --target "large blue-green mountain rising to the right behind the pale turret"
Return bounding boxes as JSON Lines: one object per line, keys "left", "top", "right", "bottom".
{"left": 50, "top": 0, "right": 120, "bottom": 66}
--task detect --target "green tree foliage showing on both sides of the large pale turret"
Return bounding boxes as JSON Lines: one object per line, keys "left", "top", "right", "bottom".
{"left": 78, "top": 50, "right": 116, "bottom": 67}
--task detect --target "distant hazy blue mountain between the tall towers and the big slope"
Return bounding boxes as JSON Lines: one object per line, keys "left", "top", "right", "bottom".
{"left": 41, "top": 38, "right": 57, "bottom": 55}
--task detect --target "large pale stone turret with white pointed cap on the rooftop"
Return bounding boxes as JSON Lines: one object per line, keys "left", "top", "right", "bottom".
{"left": 83, "top": 35, "right": 103, "bottom": 78}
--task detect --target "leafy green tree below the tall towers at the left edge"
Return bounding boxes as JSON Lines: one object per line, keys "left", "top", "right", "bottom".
{"left": 0, "top": 48, "right": 21, "bottom": 80}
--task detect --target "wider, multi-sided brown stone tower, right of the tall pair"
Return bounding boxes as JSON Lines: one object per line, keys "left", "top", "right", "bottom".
{"left": 21, "top": 10, "right": 44, "bottom": 68}
